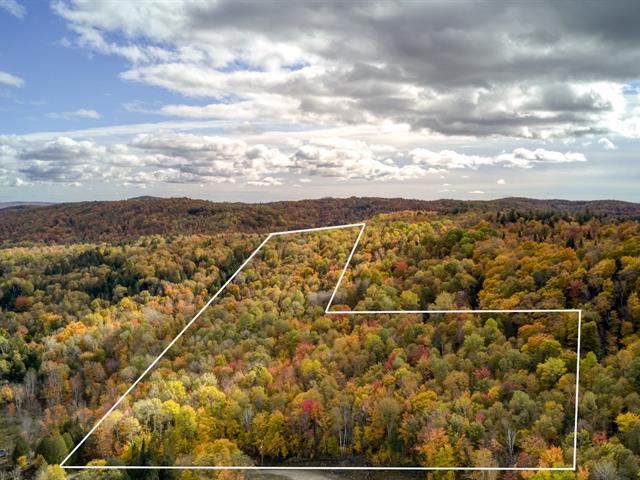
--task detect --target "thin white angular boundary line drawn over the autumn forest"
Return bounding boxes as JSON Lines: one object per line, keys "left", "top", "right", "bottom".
{"left": 60, "top": 223, "right": 582, "bottom": 471}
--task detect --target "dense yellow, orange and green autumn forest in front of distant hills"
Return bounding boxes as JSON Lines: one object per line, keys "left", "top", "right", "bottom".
{"left": 0, "top": 201, "right": 640, "bottom": 480}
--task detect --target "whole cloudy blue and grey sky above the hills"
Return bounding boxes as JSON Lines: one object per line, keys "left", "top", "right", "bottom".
{"left": 0, "top": 0, "right": 640, "bottom": 202}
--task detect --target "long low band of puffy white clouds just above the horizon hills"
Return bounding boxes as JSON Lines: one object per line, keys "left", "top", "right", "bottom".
{"left": 0, "top": 131, "right": 586, "bottom": 191}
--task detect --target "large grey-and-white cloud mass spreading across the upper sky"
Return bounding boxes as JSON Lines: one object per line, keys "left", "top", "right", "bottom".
{"left": 53, "top": 0, "right": 640, "bottom": 139}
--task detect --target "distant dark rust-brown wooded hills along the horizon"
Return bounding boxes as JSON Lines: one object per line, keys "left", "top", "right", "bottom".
{"left": 0, "top": 197, "right": 640, "bottom": 245}
